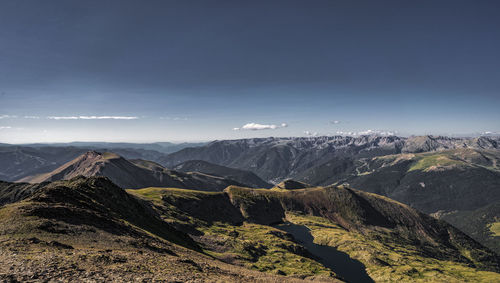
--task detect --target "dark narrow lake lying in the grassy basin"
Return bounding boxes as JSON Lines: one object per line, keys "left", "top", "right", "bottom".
{"left": 275, "top": 223, "right": 374, "bottom": 283}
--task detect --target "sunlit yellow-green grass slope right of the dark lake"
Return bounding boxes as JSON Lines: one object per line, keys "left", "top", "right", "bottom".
{"left": 287, "top": 213, "right": 500, "bottom": 282}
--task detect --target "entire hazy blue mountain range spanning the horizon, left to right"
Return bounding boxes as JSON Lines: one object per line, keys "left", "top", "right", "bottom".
{"left": 0, "top": 136, "right": 500, "bottom": 184}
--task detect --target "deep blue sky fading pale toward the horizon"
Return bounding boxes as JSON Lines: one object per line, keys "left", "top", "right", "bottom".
{"left": 0, "top": 0, "right": 500, "bottom": 142}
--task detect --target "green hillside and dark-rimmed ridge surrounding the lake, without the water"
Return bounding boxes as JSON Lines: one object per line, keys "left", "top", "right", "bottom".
{"left": 129, "top": 187, "right": 500, "bottom": 282}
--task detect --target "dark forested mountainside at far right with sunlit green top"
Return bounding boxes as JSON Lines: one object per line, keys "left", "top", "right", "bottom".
{"left": 330, "top": 149, "right": 500, "bottom": 213}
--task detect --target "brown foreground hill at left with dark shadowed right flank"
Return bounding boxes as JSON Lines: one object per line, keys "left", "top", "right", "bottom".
{"left": 0, "top": 178, "right": 334, "bottom": 282}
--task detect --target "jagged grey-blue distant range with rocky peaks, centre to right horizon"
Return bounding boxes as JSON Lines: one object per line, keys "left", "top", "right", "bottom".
{"left": 162, "top": 136, "right": 500, "bottom": 185}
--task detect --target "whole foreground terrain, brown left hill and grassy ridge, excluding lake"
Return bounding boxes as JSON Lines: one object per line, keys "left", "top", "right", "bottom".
{"left": 0, "top": 177, "right": 500, "bottom": 282}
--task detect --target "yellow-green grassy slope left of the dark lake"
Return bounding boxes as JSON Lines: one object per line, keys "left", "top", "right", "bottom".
{"left": 128, "top": 188, "right": 335, "bottom": 280}
